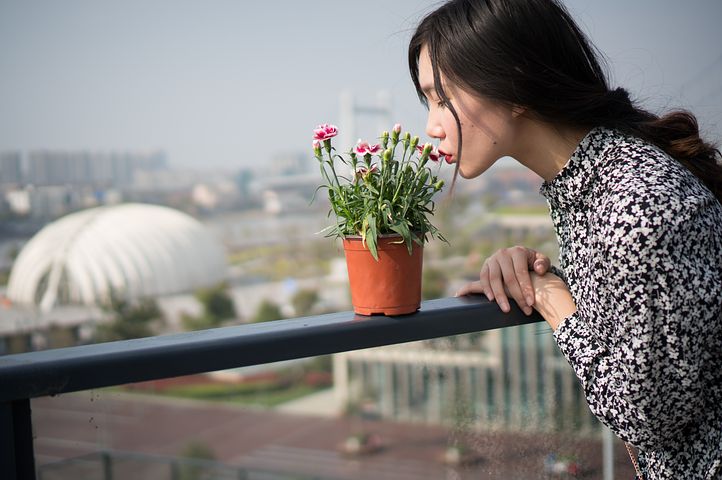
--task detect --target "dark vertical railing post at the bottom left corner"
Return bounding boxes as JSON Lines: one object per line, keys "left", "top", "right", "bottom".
{"left": 0, "top": 398, "right": 35, "bottom": 480}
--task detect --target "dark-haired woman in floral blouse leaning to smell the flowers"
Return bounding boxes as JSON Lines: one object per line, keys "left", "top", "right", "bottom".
{"left": 409, "top": 0, "right": 722, "bottom": 479}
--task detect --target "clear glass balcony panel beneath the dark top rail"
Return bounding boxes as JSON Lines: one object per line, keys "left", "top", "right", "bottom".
{"left": 32, "top": 330, "right": 633, "bottom": 480}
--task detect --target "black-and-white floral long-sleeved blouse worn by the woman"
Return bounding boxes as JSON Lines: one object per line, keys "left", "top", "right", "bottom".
{"left": 541, "top": 127, "right": 722, "bottom": 479}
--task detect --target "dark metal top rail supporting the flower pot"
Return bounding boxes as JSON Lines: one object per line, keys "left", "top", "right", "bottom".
{"left": 0, "top": 296, "right": 542, "bottom": 402}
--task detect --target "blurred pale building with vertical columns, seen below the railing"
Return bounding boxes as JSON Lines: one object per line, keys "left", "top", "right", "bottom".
{"left": 334, "top": 325, "right": 600, "bottom": 434}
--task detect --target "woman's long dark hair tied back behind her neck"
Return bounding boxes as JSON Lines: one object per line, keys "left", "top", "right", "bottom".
{"left": 409, "top": 0, "right": 722, "bottom": 202}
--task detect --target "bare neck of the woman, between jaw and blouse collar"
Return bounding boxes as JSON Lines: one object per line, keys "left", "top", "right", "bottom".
{"left": 514, "top": 118, "right": 589, "bottom": 181}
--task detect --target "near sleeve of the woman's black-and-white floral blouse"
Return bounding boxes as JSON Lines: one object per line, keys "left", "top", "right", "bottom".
{"left": 554, "top": 191, "right": 722, "bottom": 449}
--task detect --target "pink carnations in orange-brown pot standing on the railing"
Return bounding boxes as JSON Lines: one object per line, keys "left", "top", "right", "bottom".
{"left": 313, "top": 124, "right": 446, "bottom": 315}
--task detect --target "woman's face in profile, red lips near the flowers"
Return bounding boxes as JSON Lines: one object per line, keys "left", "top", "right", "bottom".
{"left": 419, "top": 47, "right": 520, "bottom": 178}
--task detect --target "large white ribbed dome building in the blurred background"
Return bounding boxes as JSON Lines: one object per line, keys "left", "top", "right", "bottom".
{"left": 7, "top": 204, "right": 226, "bottom": 311}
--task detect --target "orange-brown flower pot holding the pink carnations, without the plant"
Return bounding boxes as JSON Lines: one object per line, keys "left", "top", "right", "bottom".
{"left": 343, "top": 235, "right": 423, "bottom": 315}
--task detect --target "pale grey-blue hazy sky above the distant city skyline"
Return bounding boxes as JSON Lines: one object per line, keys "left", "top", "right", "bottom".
{"left": 0, "top": 0, "right": 722, "bottom": 168}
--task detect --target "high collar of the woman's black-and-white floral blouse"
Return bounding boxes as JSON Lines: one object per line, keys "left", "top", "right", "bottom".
{"left": 539, "top": 127, "right": 618, "bottom": 210}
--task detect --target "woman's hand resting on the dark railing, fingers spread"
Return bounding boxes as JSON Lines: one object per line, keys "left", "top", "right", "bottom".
{"left": 456, "top": 246, "right": 551, "bottom": 315}
